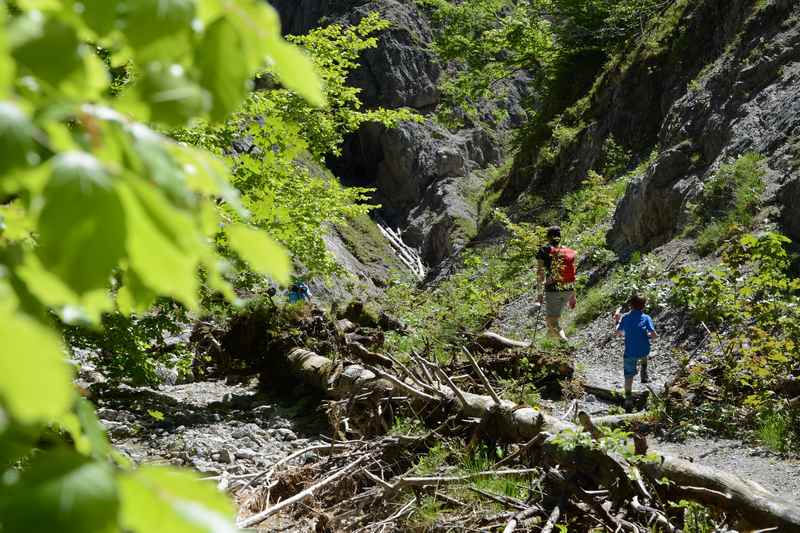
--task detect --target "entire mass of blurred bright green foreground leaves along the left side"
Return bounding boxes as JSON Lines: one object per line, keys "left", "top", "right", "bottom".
{"left": 0, "top": 0, "right": 324, "bottom": 533}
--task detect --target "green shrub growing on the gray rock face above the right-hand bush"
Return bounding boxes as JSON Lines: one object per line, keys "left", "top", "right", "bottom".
{"left": 689, "top": 153, "right": 766, "bottom": 255}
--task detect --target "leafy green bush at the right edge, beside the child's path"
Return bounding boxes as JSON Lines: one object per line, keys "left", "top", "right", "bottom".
{"left": 671, "top": 233, "right": 800, "bottom": 447}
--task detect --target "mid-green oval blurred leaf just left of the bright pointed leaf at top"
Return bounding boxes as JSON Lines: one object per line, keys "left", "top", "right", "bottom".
{"left": 195, "top": 18, "right": 251, "bottom": 121}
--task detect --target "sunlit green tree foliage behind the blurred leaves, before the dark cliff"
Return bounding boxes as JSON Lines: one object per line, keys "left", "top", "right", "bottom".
{"left": 175, "top": 14, "right": 416, "bottom": 275}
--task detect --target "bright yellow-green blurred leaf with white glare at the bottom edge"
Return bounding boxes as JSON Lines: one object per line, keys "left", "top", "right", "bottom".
{"left": 119, "top": 467, "right": 238, "bottom": 533}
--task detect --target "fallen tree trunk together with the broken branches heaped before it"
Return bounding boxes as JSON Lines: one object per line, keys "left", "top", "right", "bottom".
{"left": 239, "top": 349, "right": 800, "bottom": 532}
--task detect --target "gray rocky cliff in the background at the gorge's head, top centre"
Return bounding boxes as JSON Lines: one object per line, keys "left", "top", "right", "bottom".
{"left": 273, "top": 0, "right": 529, "bottom": 266}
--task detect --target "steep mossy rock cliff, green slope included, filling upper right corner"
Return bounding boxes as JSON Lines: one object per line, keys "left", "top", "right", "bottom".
{"left": 502, "top": 0, "right": 800, "bottom": 253}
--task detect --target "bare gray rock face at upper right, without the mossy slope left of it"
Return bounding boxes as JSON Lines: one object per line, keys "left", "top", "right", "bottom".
{"left": 609, "top": 1, "right": 800, "bottom": 251}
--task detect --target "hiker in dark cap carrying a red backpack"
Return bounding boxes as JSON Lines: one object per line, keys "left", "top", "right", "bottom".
{"left": 536, "top": 226, "right": 577, "bottom": 341}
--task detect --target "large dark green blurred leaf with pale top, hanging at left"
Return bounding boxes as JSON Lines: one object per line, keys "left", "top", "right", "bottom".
{"left": 36, "top": 152, "right": 126, "bottom": 295}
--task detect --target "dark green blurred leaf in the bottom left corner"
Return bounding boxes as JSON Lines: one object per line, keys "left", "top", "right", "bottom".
{"left": 0, "top": 450, "right": 119, "bottom": 533}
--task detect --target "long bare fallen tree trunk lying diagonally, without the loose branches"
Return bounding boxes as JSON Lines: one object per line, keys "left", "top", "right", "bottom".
{"left": 276, "top": 349, "right": 800, "bottom": 532}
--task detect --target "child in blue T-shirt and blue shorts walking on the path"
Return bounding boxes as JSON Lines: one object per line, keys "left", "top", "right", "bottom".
{"left": 614, "top": 294, "right": 658, "bottom": 412}
